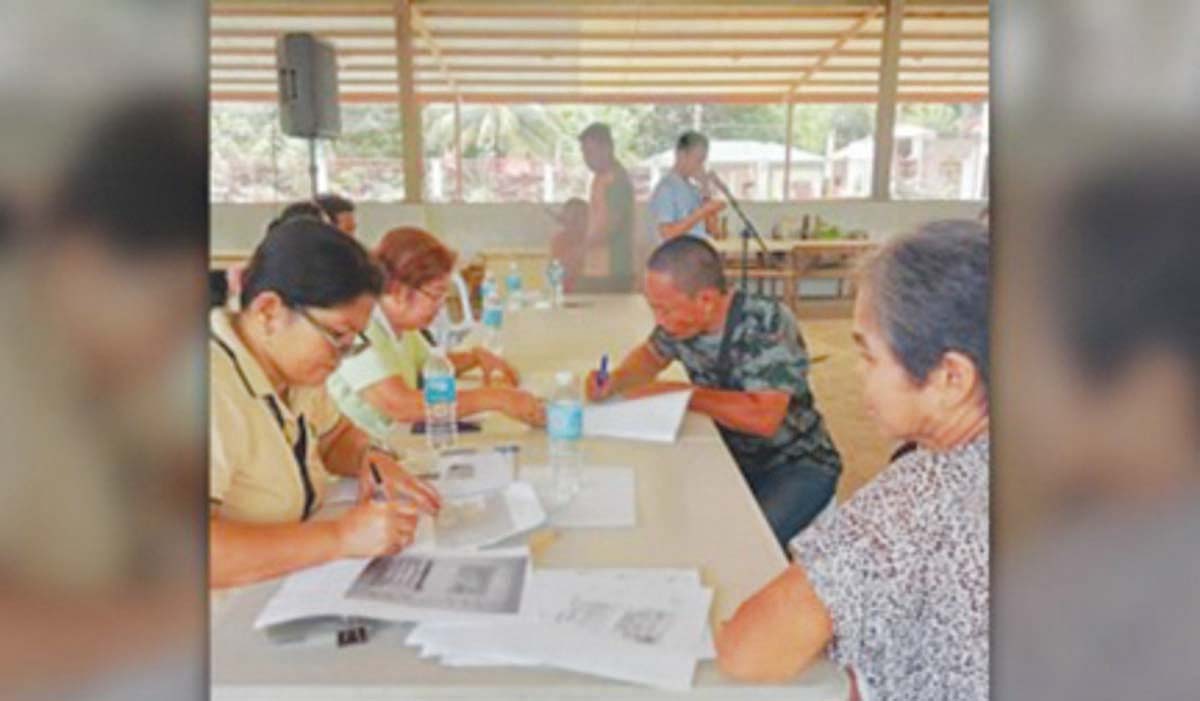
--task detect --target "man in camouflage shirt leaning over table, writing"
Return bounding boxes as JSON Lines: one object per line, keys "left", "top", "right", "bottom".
{"left": 587, "top": 236, "right": 841, "bottom": 546}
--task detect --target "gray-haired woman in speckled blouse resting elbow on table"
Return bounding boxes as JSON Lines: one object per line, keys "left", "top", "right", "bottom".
{"left": 716, "top": 220, "right": 989, "bottom": 701}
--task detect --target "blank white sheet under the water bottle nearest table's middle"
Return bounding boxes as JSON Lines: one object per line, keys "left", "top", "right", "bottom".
{"left": 521, "top": 466, "right": 637, "bottom": 528}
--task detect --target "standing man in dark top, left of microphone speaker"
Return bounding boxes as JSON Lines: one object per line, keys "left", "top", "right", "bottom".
{"left": 576, "top": 122, "right": 634, "bottom": 292}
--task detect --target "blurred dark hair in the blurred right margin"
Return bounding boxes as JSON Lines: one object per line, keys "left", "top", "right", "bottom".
{"left": 1050, "top": 160, "right": 1200, "bottom": 391}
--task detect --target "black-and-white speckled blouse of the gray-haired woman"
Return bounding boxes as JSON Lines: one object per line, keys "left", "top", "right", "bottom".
{"left": 791, "top": 435, "right": 989, "bottom": 701}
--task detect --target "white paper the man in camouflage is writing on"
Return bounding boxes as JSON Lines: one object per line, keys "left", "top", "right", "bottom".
{"left": 583, "top": 390, "right": 691, "bottom": 443}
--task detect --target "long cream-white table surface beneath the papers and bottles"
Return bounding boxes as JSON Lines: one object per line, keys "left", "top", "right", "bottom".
{"left": 211, "top": 295, "right": 848, "bottom": 701}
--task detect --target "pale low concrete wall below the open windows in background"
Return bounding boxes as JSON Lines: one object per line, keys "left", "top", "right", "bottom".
{"left": 211, "top": 200, "right": 984, "bottom": 259}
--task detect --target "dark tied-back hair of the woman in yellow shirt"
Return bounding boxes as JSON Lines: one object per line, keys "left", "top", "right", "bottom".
{"left": 241, "top": 217, "right": 383, "bottom": 308}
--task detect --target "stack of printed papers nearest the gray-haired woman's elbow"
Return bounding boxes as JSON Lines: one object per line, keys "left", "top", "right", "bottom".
{"left": 408, "top": 570, "right": 713, "bottom": 690}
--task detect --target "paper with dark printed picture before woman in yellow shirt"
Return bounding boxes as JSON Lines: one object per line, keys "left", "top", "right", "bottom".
{"left": 254, "top": 547, "right": 530, "bottom": 630}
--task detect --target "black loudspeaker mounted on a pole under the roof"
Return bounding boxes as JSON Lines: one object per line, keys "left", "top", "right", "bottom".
{"left": 275, "top": 32, "right": 342, "bottom": 139}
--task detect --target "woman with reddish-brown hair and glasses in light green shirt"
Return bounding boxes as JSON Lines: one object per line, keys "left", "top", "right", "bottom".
{"left": 328, "top": 227, "right": 545, "bottom": 439}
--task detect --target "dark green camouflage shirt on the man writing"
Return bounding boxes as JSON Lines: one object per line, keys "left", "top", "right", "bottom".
{"left": 649, "top": 293, "right": 841, "bottom": 475}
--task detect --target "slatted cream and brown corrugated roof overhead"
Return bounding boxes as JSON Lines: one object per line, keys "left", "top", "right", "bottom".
{"left": 210, "top": 0, "right": 989, "bottom": 103}
